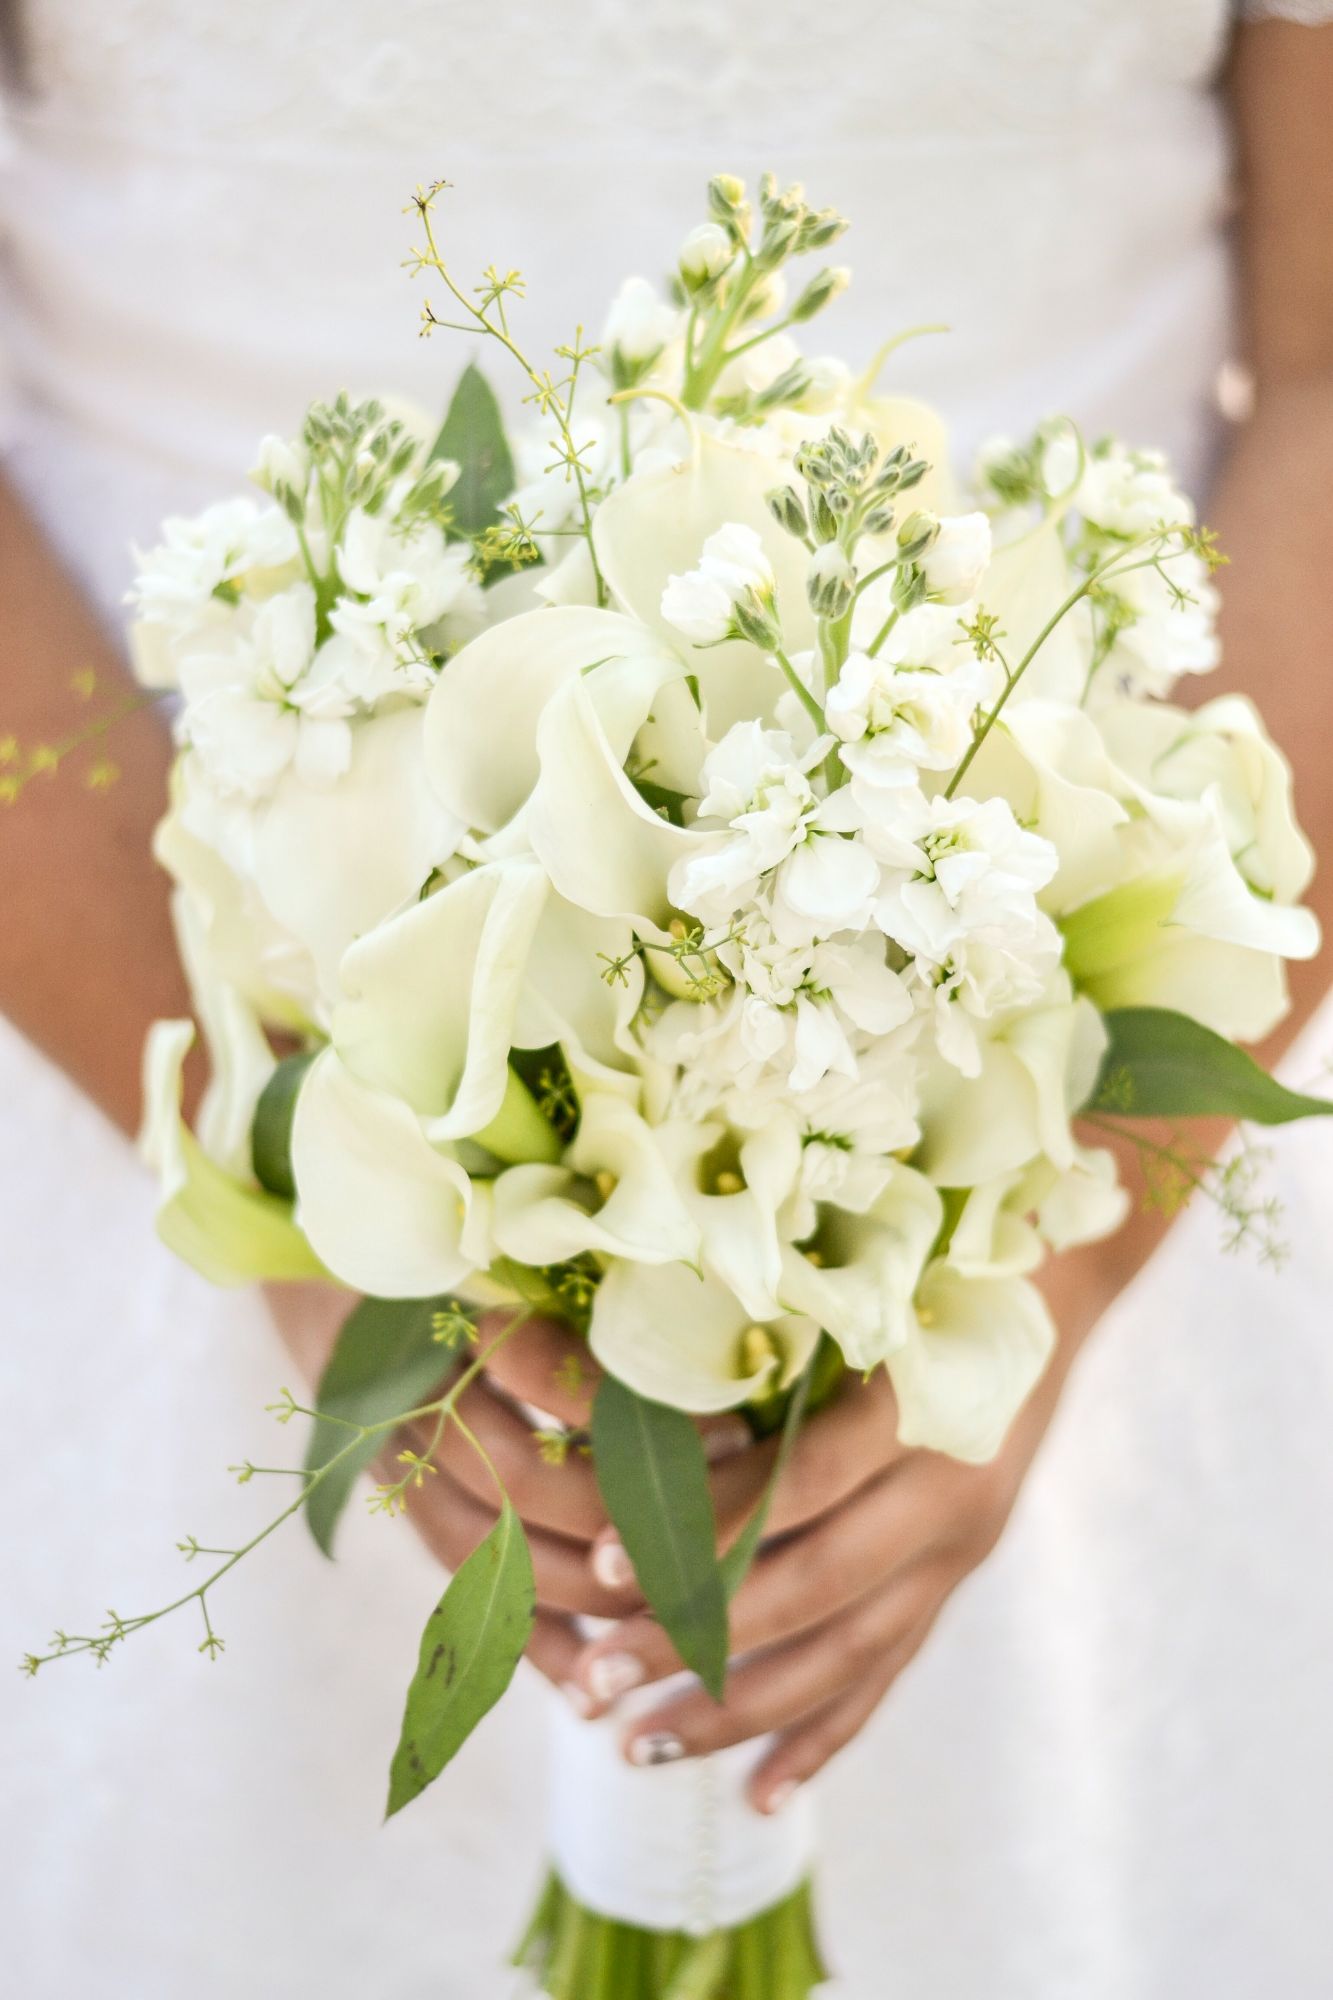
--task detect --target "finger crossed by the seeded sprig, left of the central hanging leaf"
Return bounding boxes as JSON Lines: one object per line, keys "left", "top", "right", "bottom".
{"left": 410, "top": 1380, "right": 606, "bottom": 1542}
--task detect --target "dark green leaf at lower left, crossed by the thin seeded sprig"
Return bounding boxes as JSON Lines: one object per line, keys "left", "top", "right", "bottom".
{"left": 306, "top": 1298, "right": 460, "bottom": 1556}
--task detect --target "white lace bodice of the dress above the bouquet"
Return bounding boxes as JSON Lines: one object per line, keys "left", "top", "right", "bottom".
{"left": 0, "top": 0, "right": 1333, "bottom": 616}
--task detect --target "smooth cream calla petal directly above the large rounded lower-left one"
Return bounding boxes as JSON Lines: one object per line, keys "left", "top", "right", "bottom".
{"left": 332, "top": 858, "right": 546, "bottom": 1142}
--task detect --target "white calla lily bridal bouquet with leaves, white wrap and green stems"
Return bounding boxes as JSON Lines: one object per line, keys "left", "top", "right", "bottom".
{"left": 23, "top": 176, "right": 1327, "bottom": 2000}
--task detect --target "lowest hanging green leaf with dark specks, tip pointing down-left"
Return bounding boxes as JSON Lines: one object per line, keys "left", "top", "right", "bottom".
{"left": 384, "top": 1500, "right": 536, "bottom": 1818}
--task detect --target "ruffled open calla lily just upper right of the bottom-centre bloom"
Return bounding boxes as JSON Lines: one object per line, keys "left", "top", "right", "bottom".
{"left": 783, "top": 1160, "right": 945, "bottom": 1370}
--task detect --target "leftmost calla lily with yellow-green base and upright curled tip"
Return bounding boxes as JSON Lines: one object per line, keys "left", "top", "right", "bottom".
{"left": 138, "top": 1020, "right": 326, "bottom": 1284}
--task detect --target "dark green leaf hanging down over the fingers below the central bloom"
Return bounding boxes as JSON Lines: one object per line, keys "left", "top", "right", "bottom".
{"left": 592, "top": 1376, "right": 727, "bottom": 1700}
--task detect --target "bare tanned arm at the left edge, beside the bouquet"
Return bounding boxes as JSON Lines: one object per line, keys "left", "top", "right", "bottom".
{"left": 0, "top": 464, "right": 188, "bottom": 1132}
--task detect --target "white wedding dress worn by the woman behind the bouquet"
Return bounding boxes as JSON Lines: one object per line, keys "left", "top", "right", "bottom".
{"left": 0, "top": 0, "right": 1333, "bottom": 2000}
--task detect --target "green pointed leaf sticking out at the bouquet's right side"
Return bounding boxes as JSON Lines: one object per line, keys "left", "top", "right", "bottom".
{"left": 1089, "top": 1006, "right": 1333, "bottom": 1124}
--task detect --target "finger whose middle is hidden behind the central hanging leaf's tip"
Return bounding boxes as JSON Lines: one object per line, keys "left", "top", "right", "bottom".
{"left": 578, "top": 1454, "right": 949, "bottom": 1698}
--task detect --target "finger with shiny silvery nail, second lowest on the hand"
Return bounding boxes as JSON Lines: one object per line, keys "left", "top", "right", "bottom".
{"left": 622, "top": 1568, "right": 937, "bottom": 1764}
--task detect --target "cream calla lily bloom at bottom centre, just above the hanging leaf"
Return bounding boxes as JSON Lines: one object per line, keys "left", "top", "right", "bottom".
{"left": 588, "top": 1264, "right": 819, "bottom": 1416}
